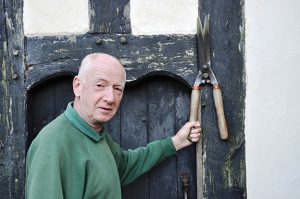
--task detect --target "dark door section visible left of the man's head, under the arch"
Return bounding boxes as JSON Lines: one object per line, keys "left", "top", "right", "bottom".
{"left": 26, "top": 76, "right": 74, "bottom": 149}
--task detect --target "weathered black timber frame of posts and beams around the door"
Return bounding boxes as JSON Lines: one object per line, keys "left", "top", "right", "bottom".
{"left": 0, "top": 0, "right": 246, "bottom": 198}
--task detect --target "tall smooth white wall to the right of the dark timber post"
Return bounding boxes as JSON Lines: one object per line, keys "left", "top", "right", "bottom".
{"left": 245, "top": 0, "right": 300, "bottom": 199}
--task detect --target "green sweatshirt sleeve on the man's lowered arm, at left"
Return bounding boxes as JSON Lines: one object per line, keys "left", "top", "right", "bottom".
{"left": 25, "top": 133, "right": 63, "bottom": 199}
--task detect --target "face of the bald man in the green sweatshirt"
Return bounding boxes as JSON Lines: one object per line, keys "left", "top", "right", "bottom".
{"left": 75, "top": 57, "right": 125, "bottom": 126}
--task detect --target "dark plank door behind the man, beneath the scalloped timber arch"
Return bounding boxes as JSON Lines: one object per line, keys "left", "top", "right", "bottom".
{"left": 27, "top": 76, "right": 196, "bottom": 199}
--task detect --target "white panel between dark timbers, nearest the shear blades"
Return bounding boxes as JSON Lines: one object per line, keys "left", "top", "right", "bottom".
{"left": 130, "top": 0, "right": 198, "bottom": 35}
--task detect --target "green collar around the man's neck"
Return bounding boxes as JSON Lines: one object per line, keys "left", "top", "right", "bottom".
{"left": 64, "top": 102, "right": 105, "bottom": 142}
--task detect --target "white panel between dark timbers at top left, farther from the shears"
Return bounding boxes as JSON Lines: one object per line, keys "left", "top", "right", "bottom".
{"left": 23, "top": 0, "right": 89, "bottom": 36}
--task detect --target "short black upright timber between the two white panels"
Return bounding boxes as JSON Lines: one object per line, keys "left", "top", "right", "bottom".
{"left": 89, "top": 0, "right": 131, "bottom": 34}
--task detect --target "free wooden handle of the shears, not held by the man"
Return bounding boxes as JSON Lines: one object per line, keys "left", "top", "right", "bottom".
{"left": 213, "top": 84, "right": 228, "bottom": 140}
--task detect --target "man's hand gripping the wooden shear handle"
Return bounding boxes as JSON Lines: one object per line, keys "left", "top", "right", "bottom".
{"left": 172, "top": 122, "right": 201, "bottom": 151}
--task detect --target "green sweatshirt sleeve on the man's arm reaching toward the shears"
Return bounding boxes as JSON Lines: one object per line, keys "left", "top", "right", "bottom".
{"left": 107, "top": 136, "right": 176, "bottom": 186}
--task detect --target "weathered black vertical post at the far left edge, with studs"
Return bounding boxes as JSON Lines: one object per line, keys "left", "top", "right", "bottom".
{"left": 0, "top": 0, "right": 26, "bottom": 199}
